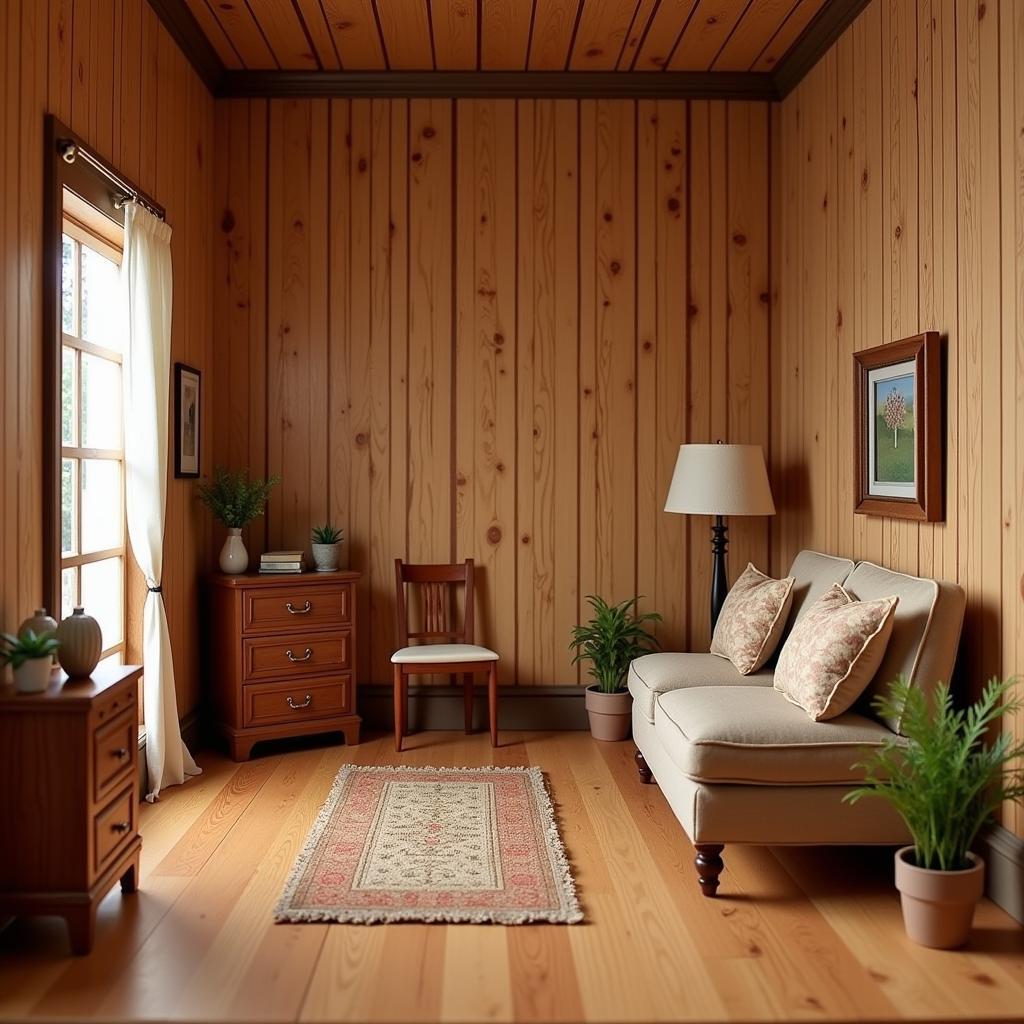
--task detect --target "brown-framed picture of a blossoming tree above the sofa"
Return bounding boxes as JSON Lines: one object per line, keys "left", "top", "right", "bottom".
{"left": 853, "top": 331, "right": 943, "bottom": 522}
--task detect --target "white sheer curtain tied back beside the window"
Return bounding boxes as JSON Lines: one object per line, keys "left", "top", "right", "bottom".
{"left": 121, "top": 204, "right": 200, "bottom": 801}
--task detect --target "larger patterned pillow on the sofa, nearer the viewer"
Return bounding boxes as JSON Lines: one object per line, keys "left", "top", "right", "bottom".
{"left": 773, "top": 583, "right": 899, "bottom": 722}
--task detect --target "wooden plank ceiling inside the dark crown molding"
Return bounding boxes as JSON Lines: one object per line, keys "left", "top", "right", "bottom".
{"left": 186, "top": 0, "right": 825, "bottom": 72}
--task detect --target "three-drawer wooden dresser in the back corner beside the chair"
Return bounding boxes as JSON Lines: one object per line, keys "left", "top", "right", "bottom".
{"left": 207, "top": 572, "right": 359, "bottom": 761}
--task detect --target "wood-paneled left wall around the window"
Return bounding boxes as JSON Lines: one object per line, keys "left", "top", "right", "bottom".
{"left": 0, "top": 0, "right": 216, "bottom": 713}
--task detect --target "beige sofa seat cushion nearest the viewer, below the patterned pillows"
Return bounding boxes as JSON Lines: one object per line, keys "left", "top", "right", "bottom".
{"left": 654, "top": 685, "right": 893, "bottom": 785}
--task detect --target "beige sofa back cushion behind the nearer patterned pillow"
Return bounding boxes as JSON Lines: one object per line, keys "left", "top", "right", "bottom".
{"left": 844, "top": 562, "right": 967, "bottom": 731}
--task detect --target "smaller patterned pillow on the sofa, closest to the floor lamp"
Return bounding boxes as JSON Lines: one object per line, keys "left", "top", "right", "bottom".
{"left": 711, "top": 562, "right": 795, "bottom": 676}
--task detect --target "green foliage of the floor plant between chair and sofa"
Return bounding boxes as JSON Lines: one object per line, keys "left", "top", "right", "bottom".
{"left": 569, "top": 594, "right": 662, "bottom": 693}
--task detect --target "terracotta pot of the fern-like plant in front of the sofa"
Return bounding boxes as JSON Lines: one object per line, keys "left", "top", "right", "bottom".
{"left": 896, "top": 846, "right": 985, "bottom": 949}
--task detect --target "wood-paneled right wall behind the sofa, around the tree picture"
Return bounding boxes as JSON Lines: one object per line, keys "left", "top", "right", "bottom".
{"left": 772, "top": 0, "right": 1024, "bottom": 836}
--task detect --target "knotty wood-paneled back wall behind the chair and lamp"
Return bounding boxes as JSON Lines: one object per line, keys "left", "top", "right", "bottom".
{"left": 214, "top": 99, "right": 769, "bottom": 685}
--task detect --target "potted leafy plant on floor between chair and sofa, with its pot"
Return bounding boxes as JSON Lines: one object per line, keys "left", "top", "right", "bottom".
{"left": 569, "top": 594, "right": 662, "bottom": 739}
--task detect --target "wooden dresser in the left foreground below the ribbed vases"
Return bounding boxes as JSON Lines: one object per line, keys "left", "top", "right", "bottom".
{"left": 0, "top": 665, "right": 142, "bottom": 953}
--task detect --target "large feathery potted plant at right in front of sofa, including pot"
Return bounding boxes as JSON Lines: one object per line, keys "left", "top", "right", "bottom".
{"left": 844, "top": 678, "right": 1024, "bottom": 949}
